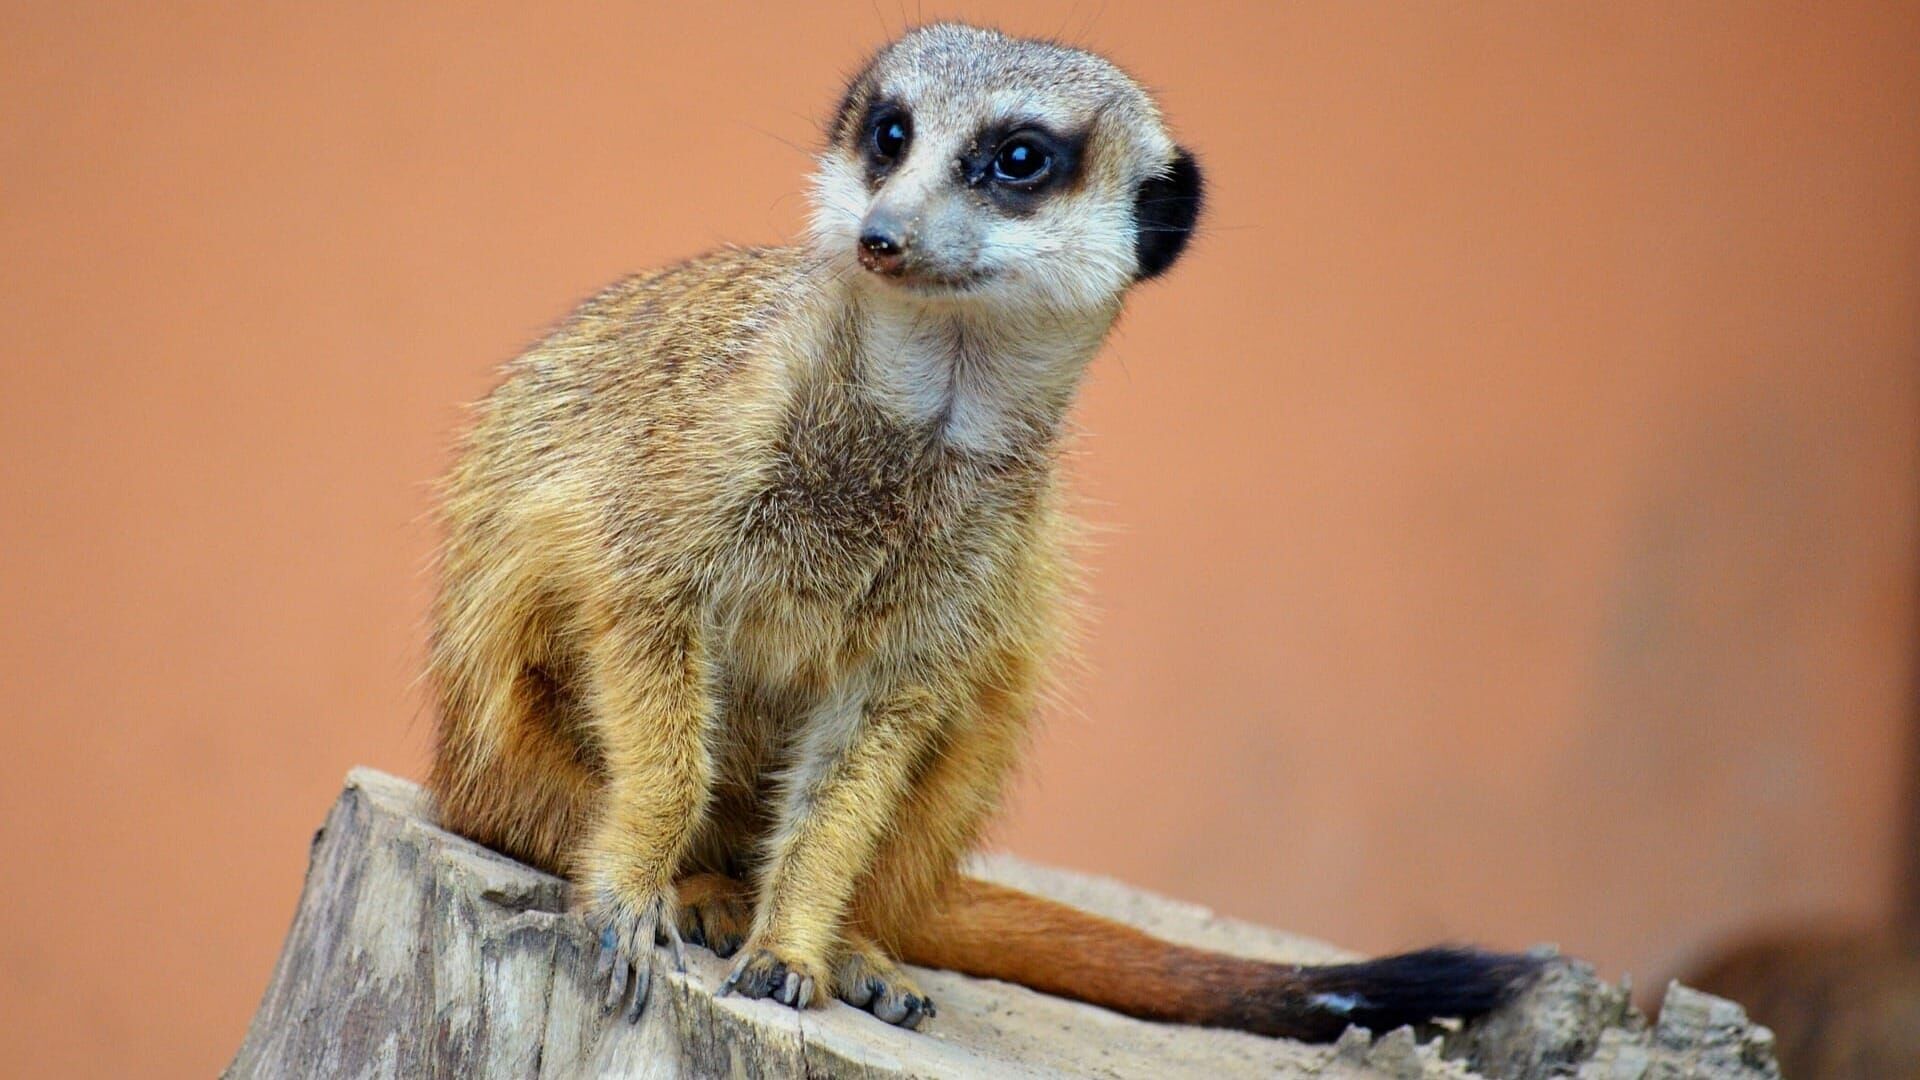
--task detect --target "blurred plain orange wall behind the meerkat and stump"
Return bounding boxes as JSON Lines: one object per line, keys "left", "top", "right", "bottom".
{"left": 0, "top": 0, "right": 1920, "bottom": 1076}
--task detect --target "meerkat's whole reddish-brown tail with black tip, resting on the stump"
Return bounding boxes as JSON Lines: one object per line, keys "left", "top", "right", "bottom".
{"left": 900, "top": 878, "right": 1544, "bottom": 1042}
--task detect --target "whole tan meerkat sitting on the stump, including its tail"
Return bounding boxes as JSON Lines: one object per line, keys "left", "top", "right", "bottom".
{"left": 428, "top": 25, "right": 1534, "bottom": 1040}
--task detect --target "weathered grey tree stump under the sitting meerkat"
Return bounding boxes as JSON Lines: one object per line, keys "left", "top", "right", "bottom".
{"left": 227, "top": 769, "right": 1778, "bottom": 1080}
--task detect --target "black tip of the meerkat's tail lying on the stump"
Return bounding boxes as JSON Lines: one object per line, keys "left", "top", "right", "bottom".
{"left": 1302, "top": 945, "right": 1549, "bottom": 1036}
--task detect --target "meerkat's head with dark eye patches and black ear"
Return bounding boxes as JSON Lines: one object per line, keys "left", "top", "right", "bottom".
{"left": 812, "top": 25, "right": 1202, "bottom": 313}
